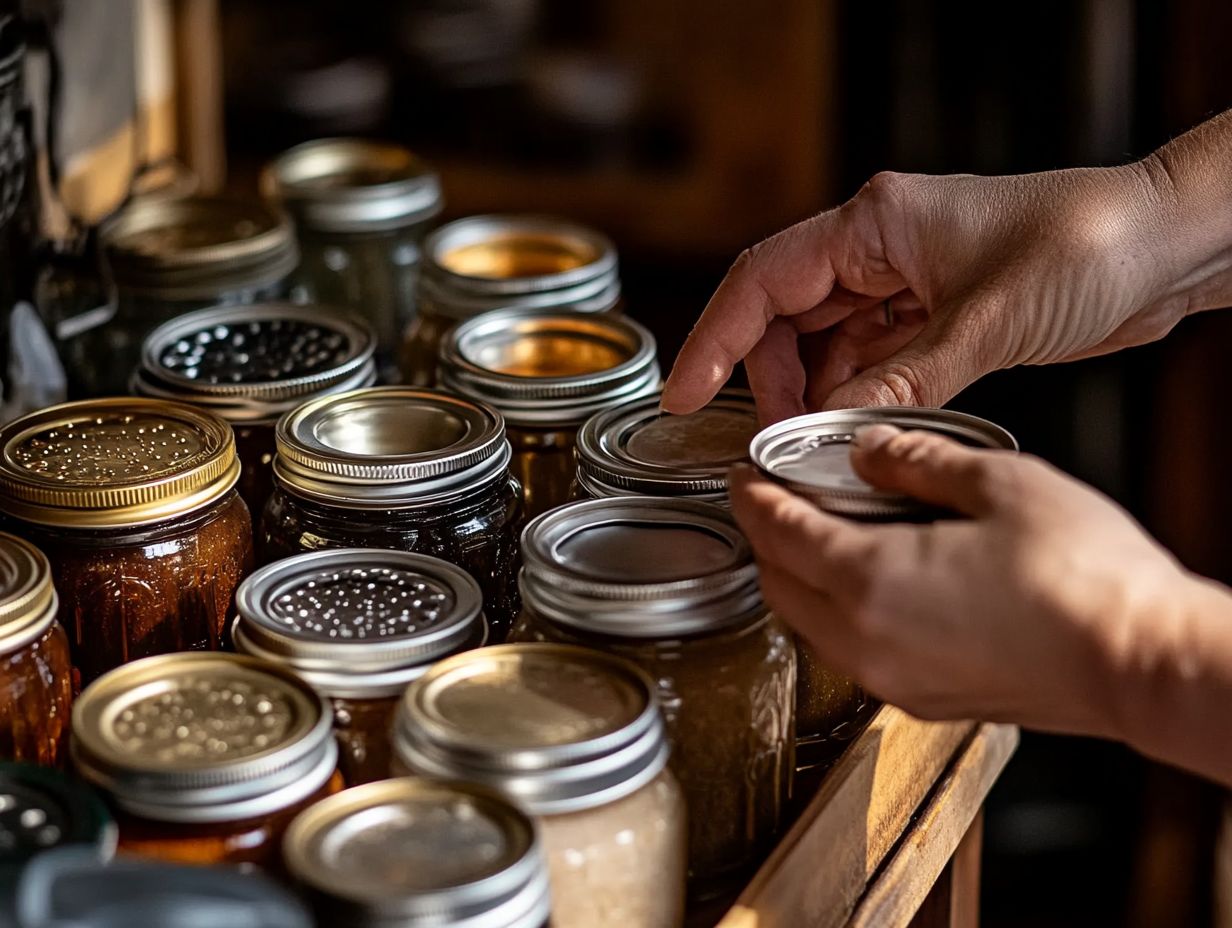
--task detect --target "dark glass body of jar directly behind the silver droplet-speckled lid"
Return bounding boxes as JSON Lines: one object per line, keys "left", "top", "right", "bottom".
{"left": 257, "top": 476, "right": 525, "bottom": 643}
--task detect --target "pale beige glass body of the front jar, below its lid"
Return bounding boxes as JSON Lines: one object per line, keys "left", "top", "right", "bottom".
{"left": 538, "top": 770, "right": 687, "bottom": 928}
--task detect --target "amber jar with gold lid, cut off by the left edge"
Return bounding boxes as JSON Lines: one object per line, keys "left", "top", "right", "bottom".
{"left": 0, "top": 532, "right": 73, "bottom": 765}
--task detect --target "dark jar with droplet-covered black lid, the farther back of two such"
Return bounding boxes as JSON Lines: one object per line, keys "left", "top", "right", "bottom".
{"left": 133, "top": 303, "right": 376, "bottom": 518}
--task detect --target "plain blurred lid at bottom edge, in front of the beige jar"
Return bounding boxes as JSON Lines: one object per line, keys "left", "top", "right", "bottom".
{"left": 282, "top": 778, "right": 549, "bottom": 928}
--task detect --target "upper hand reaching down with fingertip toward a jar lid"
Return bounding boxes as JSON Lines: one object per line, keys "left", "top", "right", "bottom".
{"left": 663, "top": 113, "right": 1232, "bottom": 423}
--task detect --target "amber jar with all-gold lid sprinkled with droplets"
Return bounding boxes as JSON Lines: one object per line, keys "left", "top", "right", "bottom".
{"left": 0, "top": 398, "right": 253, "bottom": 683}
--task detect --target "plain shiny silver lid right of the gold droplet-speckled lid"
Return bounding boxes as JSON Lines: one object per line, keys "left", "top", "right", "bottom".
{"left": 274, "top": 387, "right": 511, "bottom": 508}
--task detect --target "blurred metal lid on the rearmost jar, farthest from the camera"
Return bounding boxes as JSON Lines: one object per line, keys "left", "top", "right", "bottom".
{"left": 261, "top": 138, "right": 444, "bottom": 233}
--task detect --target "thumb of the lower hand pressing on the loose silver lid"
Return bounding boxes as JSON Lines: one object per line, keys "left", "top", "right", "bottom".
{"left": 851, "top": 424, "right": 1013, "bottom": 516}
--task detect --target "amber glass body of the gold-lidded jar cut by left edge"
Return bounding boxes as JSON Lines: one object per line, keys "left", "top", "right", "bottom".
{"left": 0, "top": 622, "right": 73, "bottom": 767}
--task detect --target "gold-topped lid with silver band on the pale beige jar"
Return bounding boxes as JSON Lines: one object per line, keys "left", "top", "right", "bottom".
{"left": 393, "top": 645, "right": 668, "bottom": 815}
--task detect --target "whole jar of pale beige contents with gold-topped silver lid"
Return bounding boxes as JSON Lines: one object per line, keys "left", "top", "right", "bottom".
{"left": 393, "top": 645, "right": 686, "bottom": 928}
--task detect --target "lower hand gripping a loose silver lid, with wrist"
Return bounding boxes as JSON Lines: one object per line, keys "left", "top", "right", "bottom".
{"left": 732, "top": 425, "right": 1232, "bottom": 783}
